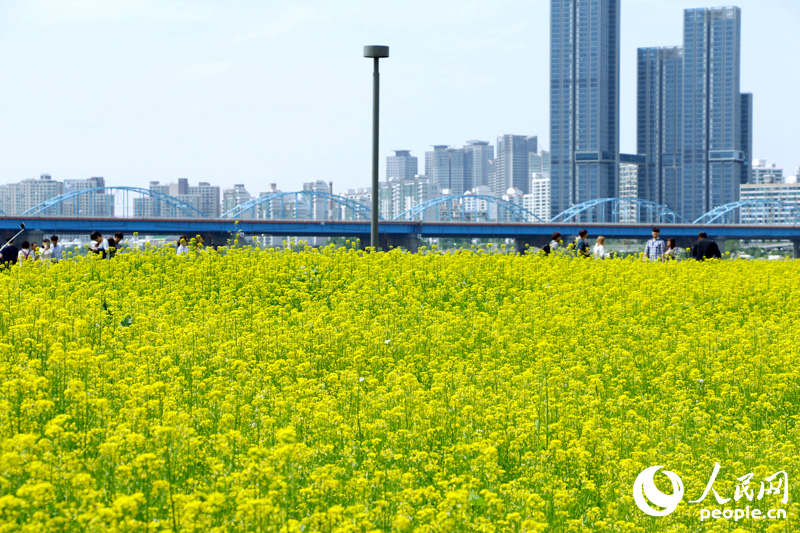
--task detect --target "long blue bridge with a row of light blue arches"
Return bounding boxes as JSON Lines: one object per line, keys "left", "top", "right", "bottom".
{"left": 0, "top": 187, "right": 800, "bottom": 257}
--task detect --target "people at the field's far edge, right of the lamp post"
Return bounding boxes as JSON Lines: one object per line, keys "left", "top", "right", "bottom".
{"left": 542, "top": 228, "right": 722, "bottom": 261}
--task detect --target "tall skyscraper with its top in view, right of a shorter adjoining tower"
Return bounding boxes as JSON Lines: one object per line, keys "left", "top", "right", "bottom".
{"left": 677, "top": 7, "right": 750, "bottom": 220}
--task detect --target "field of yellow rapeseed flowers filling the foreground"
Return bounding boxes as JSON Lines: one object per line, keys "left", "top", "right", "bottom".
{"left": 0, "top": 243, "right": 800, "bottom": 533}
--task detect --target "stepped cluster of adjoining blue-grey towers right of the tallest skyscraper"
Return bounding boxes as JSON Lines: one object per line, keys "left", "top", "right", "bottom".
{"left": 637, "top": 7, "right": 753, "bottom": 220}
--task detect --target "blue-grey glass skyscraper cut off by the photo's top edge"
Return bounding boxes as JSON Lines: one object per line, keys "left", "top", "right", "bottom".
{"left": 552, "top": 0, "right": 620, "bottom": 220}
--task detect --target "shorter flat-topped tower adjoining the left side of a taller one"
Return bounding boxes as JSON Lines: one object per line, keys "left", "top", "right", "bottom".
{"left": 636, "top": 47, "right": 683, "bottom": 209}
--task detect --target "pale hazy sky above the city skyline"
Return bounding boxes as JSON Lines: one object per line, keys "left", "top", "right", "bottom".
{"left": 0, "top": 0, "right": 800, "bottom": 192}
